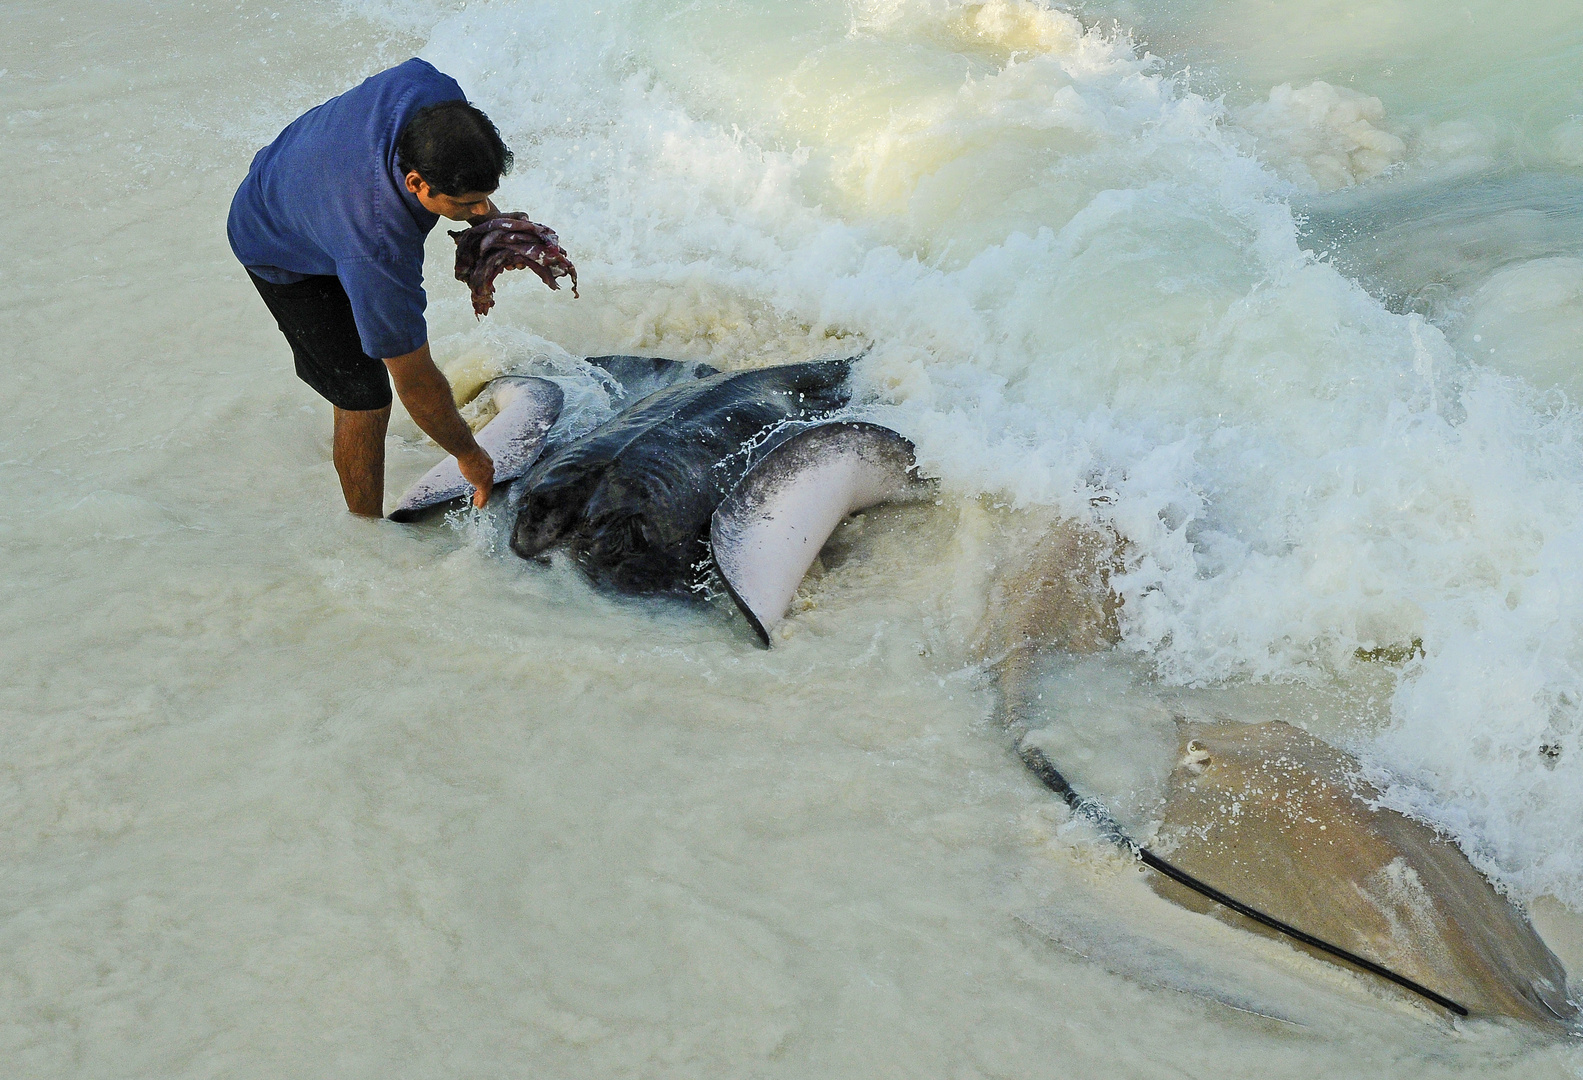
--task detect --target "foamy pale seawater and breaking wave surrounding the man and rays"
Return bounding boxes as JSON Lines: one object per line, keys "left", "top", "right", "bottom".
{"left": 9, "top": 0, "right": 1583, "bottom": 1077}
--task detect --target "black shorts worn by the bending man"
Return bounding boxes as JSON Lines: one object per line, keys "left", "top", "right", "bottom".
{"left": 247, "top": 271, "right": 391, "bottom": 412}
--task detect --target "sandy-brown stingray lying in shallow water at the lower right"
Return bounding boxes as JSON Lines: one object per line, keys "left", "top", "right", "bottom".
{"left": 1151, "top": 721, "right": 1577, "bottom": 1020}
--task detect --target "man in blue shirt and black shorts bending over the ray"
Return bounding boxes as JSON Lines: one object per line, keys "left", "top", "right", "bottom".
{"left": 226, "top": 60, "right": 511, "bottom": 518}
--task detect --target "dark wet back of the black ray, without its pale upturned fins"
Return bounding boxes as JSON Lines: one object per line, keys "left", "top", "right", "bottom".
{"left": 511, "top": 359, "right": 852, "bottom": 594}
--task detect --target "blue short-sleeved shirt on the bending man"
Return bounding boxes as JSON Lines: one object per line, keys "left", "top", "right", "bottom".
{"left": 226, "top": 59, "right": 465, "bottom": 359}
